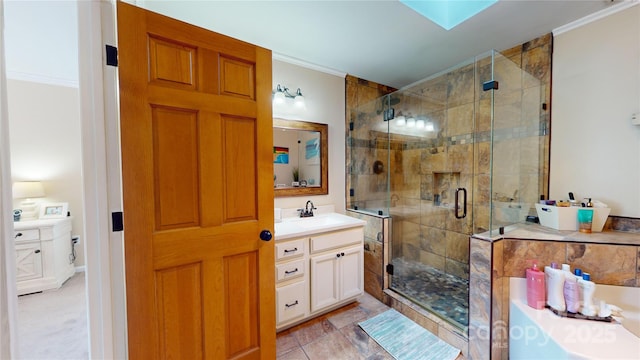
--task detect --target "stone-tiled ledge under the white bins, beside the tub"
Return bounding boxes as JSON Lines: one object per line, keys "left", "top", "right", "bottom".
{"left": 473, "top": 223, "right": 640, "bottom": 246}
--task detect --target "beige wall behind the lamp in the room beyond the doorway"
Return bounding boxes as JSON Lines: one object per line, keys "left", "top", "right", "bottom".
{"left": 7, "top": 79, "right": 86, "bottom": 266}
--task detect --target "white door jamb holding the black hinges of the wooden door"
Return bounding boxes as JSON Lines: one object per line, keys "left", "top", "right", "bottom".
{"left": 78, "top": 0, "right": 127, "bottom": 359}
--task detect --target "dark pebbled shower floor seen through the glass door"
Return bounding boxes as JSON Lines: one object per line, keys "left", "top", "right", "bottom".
{"left": 391, "top": 258, "right": 469, "bottom": 327}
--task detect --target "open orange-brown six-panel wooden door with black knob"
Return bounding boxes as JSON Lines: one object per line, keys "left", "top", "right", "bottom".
{"left": 117, "top": 2, "right": 275, "bottom": 359}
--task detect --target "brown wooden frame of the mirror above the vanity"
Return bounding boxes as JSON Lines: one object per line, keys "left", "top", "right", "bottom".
{"left": 273, "top": 119, "right": 329, "bottom": 197}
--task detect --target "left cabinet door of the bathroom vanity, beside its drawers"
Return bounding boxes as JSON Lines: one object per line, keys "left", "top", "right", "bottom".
{"left": 311, "top": 252, "right": 340, "bottom": 312}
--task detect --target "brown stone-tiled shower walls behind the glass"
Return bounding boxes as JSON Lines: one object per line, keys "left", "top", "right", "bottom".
{"left": 346, "top": 34, "right": 551, "bottom": 279}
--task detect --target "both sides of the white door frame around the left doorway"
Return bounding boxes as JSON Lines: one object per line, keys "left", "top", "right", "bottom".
{"left": 0, "top": 0, "right": 127, "bottom": 359}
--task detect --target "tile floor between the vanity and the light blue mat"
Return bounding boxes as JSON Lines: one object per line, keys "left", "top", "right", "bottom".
{"left": 276, "top": 293, "right": 393, "bottom": 360}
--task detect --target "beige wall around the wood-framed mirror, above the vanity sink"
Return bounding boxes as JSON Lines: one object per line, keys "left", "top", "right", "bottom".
{"left": 273, "top": 60, "right": 345, "bottom": 212}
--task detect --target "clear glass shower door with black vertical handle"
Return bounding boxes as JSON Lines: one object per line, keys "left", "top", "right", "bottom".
{"left": 388, "top": 56, "right": 480, "bottom": 327}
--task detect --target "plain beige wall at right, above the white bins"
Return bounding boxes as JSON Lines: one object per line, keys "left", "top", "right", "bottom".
{"left": 549, "top": 4, "right": 640, "bottom": 218}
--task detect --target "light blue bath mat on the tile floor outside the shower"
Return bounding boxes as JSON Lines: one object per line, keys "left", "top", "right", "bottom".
{"left": 358, "top": 309, "right": 460, "bottom": 360}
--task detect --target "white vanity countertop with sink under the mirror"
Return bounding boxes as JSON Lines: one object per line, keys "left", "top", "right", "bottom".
{"left": 275, "top": 213, "right": 366, "bottom": 241}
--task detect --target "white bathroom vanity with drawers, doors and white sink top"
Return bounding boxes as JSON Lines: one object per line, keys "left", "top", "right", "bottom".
{"left": 275, "top": 213, "right": 365, "bottom": 331}
